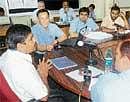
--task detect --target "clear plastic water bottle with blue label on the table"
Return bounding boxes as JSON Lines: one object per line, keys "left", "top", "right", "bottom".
{"left": 105, "top": 48, "right": 113, "bottom": 72}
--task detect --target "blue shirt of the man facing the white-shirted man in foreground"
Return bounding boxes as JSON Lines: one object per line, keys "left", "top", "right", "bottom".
{"left": 32, "top": 23, "right": 64, "bottom": 44}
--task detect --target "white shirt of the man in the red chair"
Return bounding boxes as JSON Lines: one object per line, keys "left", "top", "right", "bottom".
{"left": 0, "top": 50, "right": 48, "bottom": 102}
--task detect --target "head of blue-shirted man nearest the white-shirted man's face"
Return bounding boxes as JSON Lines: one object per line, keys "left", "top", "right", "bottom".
{"left": 37, "top": 9, "right": 49, "bottom": 27}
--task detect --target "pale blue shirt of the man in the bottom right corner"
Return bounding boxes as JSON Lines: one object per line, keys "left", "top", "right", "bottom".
{"left": 91, "top": 70, "right": 130, "bottom": 102}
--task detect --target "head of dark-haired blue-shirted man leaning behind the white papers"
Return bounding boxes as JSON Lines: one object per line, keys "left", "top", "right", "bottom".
{"left": 79, "top": 7, "right": 89, "bottom": 22}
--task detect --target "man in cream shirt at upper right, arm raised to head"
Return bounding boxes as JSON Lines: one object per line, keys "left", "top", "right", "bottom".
{"left": 101, "top": 5, "right": 129, "bottom": 33}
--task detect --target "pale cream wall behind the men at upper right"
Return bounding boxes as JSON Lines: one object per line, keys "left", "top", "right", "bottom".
{"left": 79, "top": 0, "right": 130, "bottom": 19}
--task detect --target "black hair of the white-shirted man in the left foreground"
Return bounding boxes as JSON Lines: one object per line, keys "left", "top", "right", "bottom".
{"left": 6, "top": 24, "right": 31, "bottom": 49}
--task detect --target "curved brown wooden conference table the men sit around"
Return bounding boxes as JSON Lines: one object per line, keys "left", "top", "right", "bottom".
{"left": 45, "top": 32, "right": 130, "bottom": 102}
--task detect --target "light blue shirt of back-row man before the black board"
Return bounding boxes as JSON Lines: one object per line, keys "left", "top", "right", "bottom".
{"left": 59, "top": 8, "right": 75, "bottom": 22}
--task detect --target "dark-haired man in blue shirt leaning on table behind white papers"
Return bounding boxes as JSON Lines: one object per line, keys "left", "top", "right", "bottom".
{"left": 69, "top": 7, "right": 98, "bottom": 37}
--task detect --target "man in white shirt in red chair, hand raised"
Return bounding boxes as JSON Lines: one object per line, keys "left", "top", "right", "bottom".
{"left": 0, "top": 24, "right": 51, "bottom": 102}
